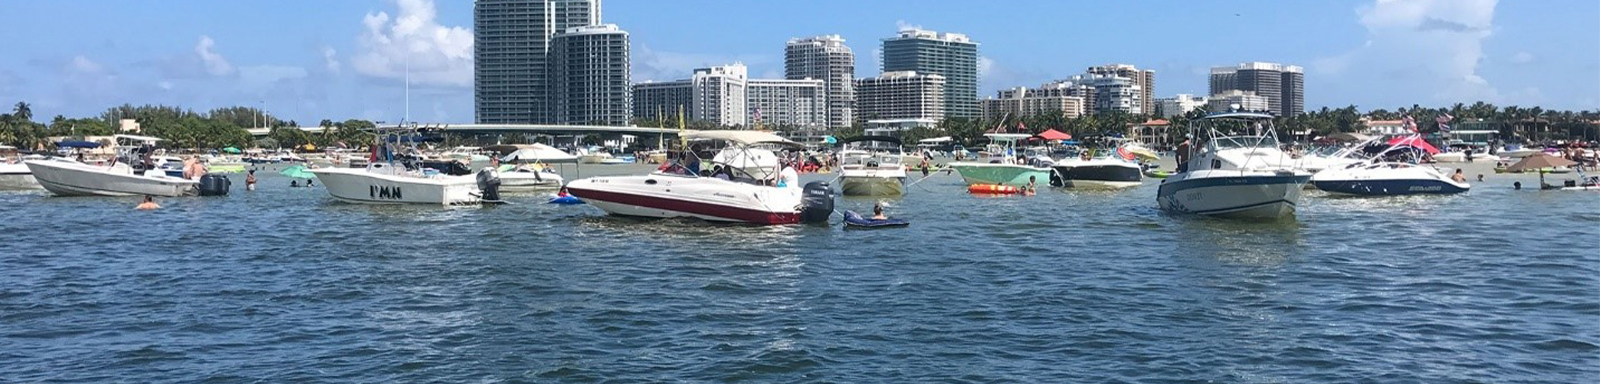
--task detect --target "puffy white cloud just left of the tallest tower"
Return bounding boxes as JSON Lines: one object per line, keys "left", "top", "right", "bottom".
{"left": 350, "top": 0, "right": 472, "bottom": 86}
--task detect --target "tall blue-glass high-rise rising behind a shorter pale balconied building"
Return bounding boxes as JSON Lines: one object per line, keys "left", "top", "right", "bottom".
{"left": 883, "top": 29, "right": 979, "bottom": 122}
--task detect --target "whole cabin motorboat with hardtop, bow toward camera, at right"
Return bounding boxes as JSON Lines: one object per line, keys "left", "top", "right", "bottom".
{"left": 1155, "top": 112, "right": 1310, "bottom": 219}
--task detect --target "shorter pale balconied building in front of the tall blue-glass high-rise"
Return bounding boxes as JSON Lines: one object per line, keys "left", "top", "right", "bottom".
{"left": 856, "top": 70, "right": 946, "bottom": 123}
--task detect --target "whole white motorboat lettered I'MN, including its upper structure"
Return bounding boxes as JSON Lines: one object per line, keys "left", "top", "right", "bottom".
{"left": 309, "top": 126, "right": 482, "bottom": 205}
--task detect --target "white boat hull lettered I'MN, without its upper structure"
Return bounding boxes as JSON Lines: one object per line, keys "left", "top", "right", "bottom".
{"left": 310, "top": 168, "right": 480, "bottom": 205}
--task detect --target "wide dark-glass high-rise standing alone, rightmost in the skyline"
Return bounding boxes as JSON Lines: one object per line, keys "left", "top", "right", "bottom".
{"left": 1210, "top": 62, "right": 1306, "bottom": 115}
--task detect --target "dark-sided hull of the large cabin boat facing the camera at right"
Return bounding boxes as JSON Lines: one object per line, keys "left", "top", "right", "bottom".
{"left": 1155, "top": 171, "right": 1310, "bottom": 219}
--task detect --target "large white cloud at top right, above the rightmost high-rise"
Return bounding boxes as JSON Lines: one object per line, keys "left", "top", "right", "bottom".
{"left": 1307, "top": 0, "right": 1501, "bottom": 104}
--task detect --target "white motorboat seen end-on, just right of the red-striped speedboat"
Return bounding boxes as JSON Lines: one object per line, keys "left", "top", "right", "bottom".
{"left": 838, "top": 136, "right": 906, "bottom": 197}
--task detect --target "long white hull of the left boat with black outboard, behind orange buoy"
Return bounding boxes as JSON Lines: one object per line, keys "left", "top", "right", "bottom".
{"left": 27, "top": 160, "right": 200, "bottom": 197}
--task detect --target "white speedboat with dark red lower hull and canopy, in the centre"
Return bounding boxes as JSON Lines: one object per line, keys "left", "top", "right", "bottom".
{"left": 566, "top": 131, "right": 834, "bottom": 224}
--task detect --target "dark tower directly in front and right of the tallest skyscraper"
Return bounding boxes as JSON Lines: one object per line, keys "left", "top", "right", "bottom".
{"left": 549, "top": 24, "right": 634, "bottom": 125}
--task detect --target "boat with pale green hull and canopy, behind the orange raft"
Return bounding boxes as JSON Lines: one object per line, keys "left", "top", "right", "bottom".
{"left": 950, "top": 133, "right": 1050, "bottom": 186}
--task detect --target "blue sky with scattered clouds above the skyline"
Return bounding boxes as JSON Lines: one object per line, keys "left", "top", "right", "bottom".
{"left": 0, "top": 0, "right": 1600, "bottom": 125}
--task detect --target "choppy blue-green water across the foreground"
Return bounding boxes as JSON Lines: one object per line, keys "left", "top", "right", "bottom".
{"left": 0, "top": 163, "right": 1600, "bottom": 382}
